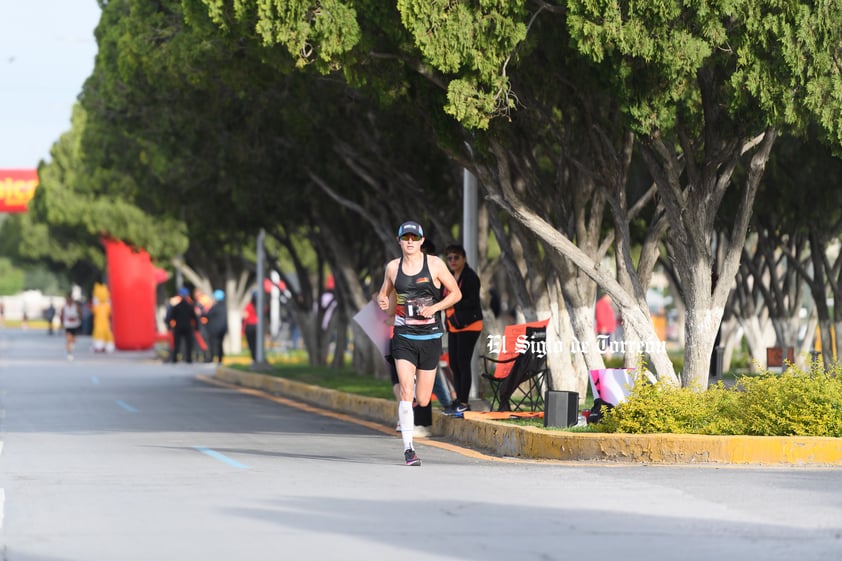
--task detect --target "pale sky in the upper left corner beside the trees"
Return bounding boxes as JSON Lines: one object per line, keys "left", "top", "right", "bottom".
{"left": 0, "top": 0, "right": 100, "bottom": 169}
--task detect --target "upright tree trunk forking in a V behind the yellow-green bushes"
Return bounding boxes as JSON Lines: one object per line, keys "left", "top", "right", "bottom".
{"left": 641, "top": 121, "right": 777, "bottom": 390}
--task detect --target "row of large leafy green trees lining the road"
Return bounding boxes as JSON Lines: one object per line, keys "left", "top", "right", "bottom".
{"left": 1, "top": 0, "right": 842, "bottom": 390}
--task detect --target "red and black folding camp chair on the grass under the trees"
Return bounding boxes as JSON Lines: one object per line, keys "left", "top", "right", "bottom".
{"left": 480, "top": 319, "right": 549, "bottom": 411}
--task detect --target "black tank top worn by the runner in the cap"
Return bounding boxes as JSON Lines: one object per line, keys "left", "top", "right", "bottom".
{"left": 395, "top": 255, "right": 442, "bottom": 336}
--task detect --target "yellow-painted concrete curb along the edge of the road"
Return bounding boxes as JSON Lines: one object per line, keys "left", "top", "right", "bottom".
{"left": 215, "top": 366, "right": 842, "bottom": 466}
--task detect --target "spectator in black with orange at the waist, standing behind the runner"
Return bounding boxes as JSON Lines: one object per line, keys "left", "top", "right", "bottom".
{"left": 444, "top": 245, "right": 482, "bottom": 414}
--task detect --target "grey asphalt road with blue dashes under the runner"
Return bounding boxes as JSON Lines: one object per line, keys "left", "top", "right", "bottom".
{"left": 0, "top": 328, "right": 842, "bottom": 561}
